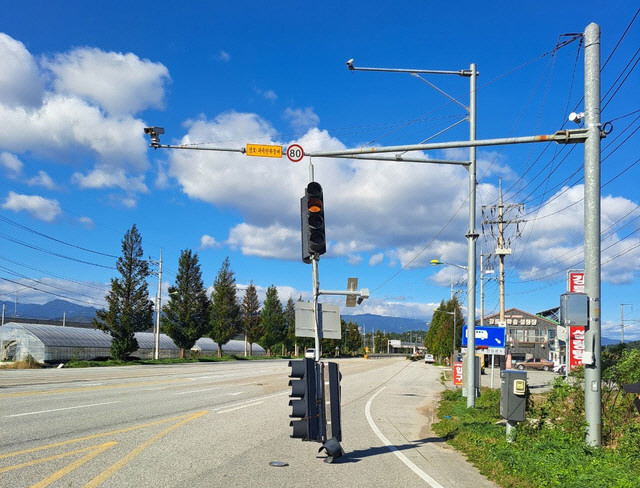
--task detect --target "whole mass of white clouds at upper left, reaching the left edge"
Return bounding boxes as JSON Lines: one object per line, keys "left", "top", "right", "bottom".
{"left": 0, "top": 34, "right": 170, "bottom": 191}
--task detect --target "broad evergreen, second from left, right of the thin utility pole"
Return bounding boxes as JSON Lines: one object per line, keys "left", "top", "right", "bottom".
{"left": 160, "top": 249, "right": 211, "bottom": 358}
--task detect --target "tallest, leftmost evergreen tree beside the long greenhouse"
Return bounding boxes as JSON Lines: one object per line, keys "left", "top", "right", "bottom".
{"left": 93, "top": 224, "right": 153, "bottom": 360}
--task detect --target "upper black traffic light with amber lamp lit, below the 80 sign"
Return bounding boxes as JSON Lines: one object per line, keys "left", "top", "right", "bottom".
{"left": 300, "top": 181, "right": 327, "bottom": 264}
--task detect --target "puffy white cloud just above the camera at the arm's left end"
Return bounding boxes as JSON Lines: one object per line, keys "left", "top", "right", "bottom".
{"left": 43, "top": 48, "right": 170, "bottom": 115}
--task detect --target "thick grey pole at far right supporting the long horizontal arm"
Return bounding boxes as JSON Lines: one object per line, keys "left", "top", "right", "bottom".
{"left": 583, "top": 24, "right": 602, "bottom": 446}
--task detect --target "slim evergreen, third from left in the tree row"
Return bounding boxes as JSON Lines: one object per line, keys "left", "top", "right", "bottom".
{"left": 209, "top": 256, "right": 241, "bottom": 357}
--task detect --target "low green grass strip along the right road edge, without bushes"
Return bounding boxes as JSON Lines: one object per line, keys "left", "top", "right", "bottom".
{"left": 433, "top": 389, "right": 640, "bottom": 488}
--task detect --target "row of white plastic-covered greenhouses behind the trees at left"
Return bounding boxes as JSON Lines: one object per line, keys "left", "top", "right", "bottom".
{"left": 0, "top": 322, "right": 265, "bottom": 363}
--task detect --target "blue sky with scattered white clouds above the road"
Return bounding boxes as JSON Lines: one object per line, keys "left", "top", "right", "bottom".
{"left": 0, "top": 0, "right": 640, "bottom": 339}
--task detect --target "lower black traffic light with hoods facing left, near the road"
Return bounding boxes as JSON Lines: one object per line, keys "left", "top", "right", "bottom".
{"left": 289, "top": 358, "right": 320, "bottom": 441}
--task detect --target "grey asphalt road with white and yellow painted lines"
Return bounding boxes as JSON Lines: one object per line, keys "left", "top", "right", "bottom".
{"left": 0, "top": 358, "right": 494, "bottom": 488}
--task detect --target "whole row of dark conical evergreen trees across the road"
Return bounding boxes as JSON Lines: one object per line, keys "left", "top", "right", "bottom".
{"left": 94, "top": 224, "right": 362, "bottom": 359}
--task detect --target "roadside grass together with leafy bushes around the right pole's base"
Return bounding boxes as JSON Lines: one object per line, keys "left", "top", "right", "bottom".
{"left": 432, "top": 350, "right": 640, "bottom": 488}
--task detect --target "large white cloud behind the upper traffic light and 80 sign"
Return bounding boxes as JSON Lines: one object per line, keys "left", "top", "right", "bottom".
{"left": 169, "top": 112, "right": 476, "bottom": 267}
